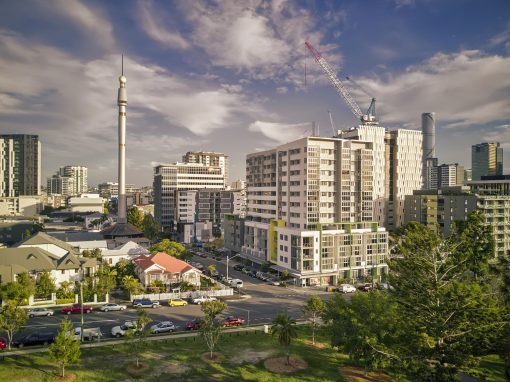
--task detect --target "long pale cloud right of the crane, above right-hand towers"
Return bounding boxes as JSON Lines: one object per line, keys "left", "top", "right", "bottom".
{"left": 352, "top": 50, "right": 510, "bottom": 127}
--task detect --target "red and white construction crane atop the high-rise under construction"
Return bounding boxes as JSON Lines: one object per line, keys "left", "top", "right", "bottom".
{"left": 305, "top": 41, "right": 377, "bottom": 125}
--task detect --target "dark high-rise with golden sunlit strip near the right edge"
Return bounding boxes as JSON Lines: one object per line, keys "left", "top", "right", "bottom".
{"left": 471, "top": 142, "right": 503, "bottom": 180}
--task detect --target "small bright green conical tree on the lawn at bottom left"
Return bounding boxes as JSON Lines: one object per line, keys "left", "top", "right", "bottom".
{"left": 49, "top": 318, "right": 81, "bottom": 378}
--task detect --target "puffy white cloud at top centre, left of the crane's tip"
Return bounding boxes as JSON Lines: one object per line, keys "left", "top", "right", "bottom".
{"left": 183, "top": 0, "right": 341, "bottom": 87}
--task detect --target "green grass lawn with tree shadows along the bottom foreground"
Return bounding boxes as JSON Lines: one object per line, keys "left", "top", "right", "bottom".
{"left": 0, "top": 328, "right": 505, "bottom": 382}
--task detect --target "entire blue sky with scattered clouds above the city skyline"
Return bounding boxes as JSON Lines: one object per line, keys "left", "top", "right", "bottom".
{"left": 0, "top": 0, "right": 510, "bottom": 186}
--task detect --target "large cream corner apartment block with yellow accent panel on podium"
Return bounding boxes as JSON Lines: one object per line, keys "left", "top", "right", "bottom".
{"left": 225, "top": 137, "right": 388, "bottom": 285}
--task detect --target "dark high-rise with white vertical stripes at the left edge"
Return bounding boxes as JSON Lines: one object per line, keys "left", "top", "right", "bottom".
{"left": 0, "top": 134, "right": 41, "bottom": 197}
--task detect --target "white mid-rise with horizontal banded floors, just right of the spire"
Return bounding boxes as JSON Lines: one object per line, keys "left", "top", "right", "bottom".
{"left": 154, "top": 163, "right": 225, "bottom": 230}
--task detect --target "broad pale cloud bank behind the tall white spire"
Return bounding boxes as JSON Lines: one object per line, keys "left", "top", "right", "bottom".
{"left": 0, "top": 31, "right": 252, "bottom": 183}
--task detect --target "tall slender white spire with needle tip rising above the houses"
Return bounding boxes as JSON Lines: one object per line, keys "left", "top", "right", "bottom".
{"left": 117, "top": 56, "right": 127, "bottom": 224}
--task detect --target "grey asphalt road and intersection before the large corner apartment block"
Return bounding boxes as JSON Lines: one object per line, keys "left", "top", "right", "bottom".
{"left": 3, "top": 252, "right": 332, "bottom": 344}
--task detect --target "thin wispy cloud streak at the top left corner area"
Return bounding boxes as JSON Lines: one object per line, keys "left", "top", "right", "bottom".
{"left": 40, "top": 0, "right": 115, "bottom": 50}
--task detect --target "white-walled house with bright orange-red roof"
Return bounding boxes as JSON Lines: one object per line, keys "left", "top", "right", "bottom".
{"left": 134, "top": 252, "right": 201, "bottom": 287}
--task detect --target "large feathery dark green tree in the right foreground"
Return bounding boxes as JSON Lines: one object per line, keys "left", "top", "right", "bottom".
{"left": 327, "top": 223, "right": 505, "bottom": 381}
